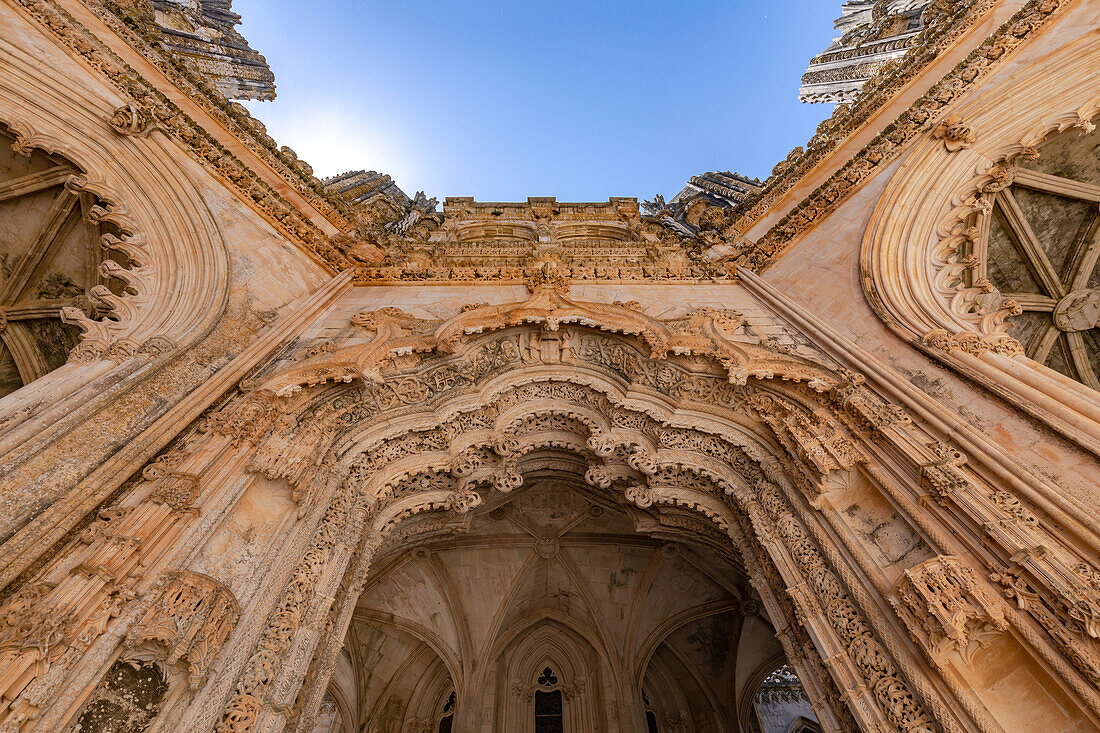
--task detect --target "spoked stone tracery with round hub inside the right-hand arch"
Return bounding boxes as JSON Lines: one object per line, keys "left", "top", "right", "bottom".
{"left": 975, "top": 124, "right": 1100, "bottom": 390}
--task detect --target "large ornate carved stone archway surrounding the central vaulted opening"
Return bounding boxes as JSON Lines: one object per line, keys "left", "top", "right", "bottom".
{"left": 8, "top": 285, "right": 1100, "bottom": 733}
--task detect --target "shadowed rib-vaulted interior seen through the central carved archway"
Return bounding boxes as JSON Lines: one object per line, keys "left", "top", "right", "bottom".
{"left": 325, "top": 457, "right": 800, "bottom": 733}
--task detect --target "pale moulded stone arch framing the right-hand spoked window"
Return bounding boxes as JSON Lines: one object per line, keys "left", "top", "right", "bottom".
{"left": 861, "top": 24, "right": 1100, "bottom": 452}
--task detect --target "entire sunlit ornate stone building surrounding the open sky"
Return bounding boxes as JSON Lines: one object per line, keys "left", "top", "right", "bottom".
{"left": 0, "top": 0, "right": 1100, "bottom": 733}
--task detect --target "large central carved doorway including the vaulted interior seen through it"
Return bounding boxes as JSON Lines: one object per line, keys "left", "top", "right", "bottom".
{"left": 21, "top": 286, "right": 1095, "bottom": 733}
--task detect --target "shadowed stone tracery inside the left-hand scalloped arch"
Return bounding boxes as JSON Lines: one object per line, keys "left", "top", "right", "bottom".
{"left": 0, "top": 128, "right": 130, "bottom": 397}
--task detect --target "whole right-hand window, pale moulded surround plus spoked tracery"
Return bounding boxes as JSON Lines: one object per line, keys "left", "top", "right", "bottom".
{"left": 860, "top": 48, "right": 1100, "bottom": 444}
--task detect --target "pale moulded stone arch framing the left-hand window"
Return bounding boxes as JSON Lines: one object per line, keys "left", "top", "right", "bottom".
{"left": 0, "top": 44, "right": 230, "bottom": 445}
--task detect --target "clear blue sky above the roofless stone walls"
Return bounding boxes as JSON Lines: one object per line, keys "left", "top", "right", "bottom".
{"left": 233, "top": 0, "right": 840, "bottom": 200}
